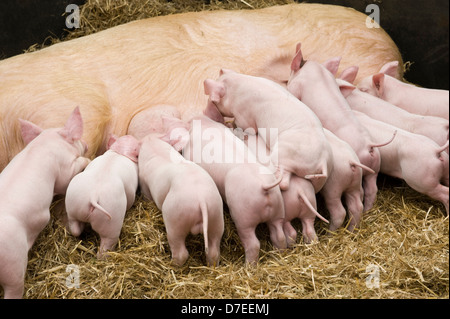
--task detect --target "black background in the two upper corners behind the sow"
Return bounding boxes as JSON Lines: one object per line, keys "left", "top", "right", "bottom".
{"left": 0, "top": 0, "right": 449, "bottom": 90}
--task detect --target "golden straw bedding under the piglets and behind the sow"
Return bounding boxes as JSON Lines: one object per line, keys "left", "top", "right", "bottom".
{"left": 4, "top": 0, "right": 449, "bottom": 298}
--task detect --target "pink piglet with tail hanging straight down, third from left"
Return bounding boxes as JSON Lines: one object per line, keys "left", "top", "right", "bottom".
{"left": 138, "top": 133, "right": 224, "bottom": 266}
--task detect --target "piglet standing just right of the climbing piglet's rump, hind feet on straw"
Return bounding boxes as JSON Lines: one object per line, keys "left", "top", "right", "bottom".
{"left": 320, "top": 129, "right": 370, "bottom": 231}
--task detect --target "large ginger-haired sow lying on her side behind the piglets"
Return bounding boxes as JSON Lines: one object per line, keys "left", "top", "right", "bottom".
{"left": 0, "top": 3, "right": 402, "bottom": 170}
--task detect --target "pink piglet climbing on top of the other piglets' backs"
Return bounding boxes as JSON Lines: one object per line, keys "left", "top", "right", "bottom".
{"left": 204, "top": 70, "right": 332, "bottom": 191}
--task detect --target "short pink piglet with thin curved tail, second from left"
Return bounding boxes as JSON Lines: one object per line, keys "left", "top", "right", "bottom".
{"left": 65, "top": 135, "right": 140, "bottom": 258}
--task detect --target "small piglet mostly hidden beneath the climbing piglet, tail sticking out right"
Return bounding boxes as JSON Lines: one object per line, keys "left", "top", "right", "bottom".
{"left": 241, "top": 132, "right": 332, "bottom": 247}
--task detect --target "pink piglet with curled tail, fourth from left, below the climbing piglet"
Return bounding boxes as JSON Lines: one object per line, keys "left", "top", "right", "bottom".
{"left": 165, "top": 116, "right": 286, "bottom": 264}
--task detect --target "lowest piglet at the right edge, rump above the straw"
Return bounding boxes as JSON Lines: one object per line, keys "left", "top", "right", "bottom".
{"left": 353, "top": 111, "right": 449, "bottom": 215}
